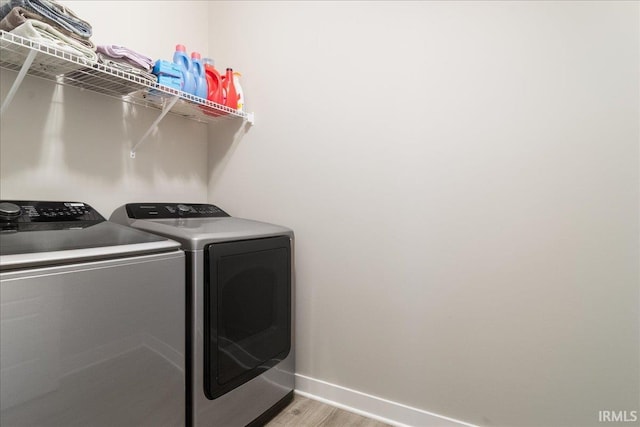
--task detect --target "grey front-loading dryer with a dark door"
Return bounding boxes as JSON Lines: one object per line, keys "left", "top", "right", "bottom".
{"left": 110, "top": 203, "right": 295, "bottom": 427}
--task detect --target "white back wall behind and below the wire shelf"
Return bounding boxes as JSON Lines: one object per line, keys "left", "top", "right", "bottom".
{"left": 0, "top": 1, "right": 209, "bottom": 217}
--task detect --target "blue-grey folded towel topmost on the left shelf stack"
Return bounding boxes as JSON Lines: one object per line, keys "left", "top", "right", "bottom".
{"left": 0, "top": 0, "right": 92, "bottom": 38}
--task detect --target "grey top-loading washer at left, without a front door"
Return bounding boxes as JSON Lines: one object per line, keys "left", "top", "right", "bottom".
{"left": 0, "top": 200, "right": 186, "bottom": 427}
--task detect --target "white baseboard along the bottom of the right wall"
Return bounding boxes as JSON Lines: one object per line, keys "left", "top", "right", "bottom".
{"left": 296, "top": 374, "right": 477, "bottom": 427}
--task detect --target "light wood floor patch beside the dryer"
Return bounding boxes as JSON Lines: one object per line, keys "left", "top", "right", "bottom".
{"left": 265, "top": 394, "right": 389, "bottom": 427}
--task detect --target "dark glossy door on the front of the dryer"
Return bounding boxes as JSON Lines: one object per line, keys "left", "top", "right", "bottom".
{"left": 204, "top": 236, "right": 291, "bottom": 400}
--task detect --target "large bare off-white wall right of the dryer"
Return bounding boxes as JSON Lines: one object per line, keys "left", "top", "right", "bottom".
{"left": 209, "top": 1, "right": 640, "bottom": 427}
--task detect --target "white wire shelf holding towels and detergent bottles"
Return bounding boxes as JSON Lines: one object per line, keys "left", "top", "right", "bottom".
{"left": 0, "top": 31, "right": 253, "bottom": 123}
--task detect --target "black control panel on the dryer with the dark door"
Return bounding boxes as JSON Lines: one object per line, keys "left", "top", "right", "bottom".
{"left": 126, "top": 203, "right": 229, "bottom": 219}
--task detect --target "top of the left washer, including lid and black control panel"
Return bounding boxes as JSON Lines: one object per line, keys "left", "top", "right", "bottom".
{"left": 0, "top": 201, "right": 180, "bottom": 270}
